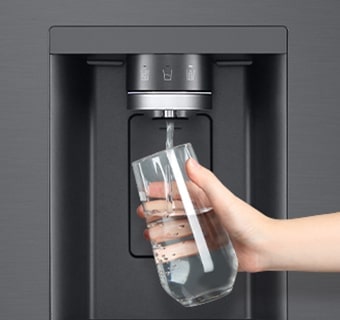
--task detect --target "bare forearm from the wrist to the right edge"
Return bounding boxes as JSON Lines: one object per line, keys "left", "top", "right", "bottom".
{"left": 263, "top": 212, "right": 340, "bottom": 272}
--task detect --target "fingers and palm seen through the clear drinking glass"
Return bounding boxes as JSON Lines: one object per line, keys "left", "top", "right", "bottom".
{"left": 137, "top": 181, "right": 229, "bottom": 263}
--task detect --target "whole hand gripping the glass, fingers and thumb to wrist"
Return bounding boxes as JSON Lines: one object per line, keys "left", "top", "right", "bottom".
{"left": 137, "top": 159, "right": 272, "bottom": 272}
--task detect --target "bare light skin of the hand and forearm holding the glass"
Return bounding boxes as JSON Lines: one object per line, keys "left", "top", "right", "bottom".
{"left": 137, "top": 159, "right": 340, "bottom": 272}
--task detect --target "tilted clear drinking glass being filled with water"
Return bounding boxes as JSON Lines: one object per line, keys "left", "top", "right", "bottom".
{"left": 132, "top": 143, "right": 238, "bottom": 307}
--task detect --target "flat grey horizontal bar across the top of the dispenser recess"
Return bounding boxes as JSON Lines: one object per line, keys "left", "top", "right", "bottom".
{"left": 50, "top": 25, "right": 287, "bottom": 54}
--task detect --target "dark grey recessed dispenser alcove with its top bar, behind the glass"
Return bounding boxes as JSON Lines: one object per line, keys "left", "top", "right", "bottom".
{"left": 50, "top": 27, "right": 287, "bottom": 320}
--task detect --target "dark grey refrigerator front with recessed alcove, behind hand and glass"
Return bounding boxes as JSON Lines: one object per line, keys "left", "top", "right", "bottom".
{"left": 0, "top": 0, "right": 340, "bottom": 320}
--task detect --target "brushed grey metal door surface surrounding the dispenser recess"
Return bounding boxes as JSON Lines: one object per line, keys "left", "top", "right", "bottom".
{"left": 0, "top": 0, "right": 340, "bottom": 320}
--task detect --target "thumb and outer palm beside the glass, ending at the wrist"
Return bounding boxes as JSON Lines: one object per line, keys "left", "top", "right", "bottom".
{"left": 186, "top": 159, "right": 274, "bottom": 272}
